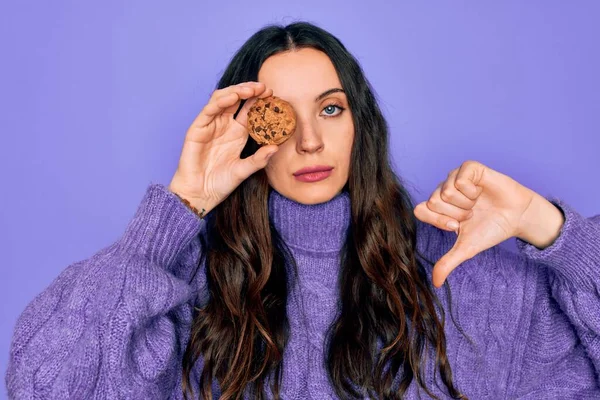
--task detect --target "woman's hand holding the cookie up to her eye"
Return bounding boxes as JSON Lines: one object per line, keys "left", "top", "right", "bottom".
{"left": 169, "top": 82, "right": 278, "bottom": 213}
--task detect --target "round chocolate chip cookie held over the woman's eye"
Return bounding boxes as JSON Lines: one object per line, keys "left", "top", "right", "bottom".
{"left": 248, "top": 96, "right": 296, "bottom": 146}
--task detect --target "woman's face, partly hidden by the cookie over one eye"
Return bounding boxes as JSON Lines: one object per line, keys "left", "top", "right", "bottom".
{"left": 258, "top": 48, "right": 354, "bottom": 204}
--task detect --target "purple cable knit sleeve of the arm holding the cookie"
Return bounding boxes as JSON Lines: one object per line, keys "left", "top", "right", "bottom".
{"left": 6, "top": 184, "right": 206, "bottom": 399}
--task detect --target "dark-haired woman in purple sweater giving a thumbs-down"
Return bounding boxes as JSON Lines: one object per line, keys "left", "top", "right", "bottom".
{"left": 6, "top": 23, "right": 600, "bottom": 399}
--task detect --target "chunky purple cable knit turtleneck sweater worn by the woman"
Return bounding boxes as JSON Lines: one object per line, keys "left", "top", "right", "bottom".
{"left": 6, "top": 183, "right": 600, "bottom": 400}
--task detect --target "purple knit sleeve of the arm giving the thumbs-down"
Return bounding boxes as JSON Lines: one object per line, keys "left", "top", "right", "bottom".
{"left": 510, "top": 197, "right": 600, "bottom": 399}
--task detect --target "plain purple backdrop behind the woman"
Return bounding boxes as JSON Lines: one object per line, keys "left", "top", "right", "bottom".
{"left": 0, "top": 0, "right": 600, "bottom": 397}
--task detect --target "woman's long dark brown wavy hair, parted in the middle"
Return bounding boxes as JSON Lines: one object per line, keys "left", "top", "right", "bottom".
{"left": 182, "top": 22, "right": 474, "bottom": 400}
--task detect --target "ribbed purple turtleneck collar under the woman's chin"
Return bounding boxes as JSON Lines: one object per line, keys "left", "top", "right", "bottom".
{"left": 269, "top": 189, "right": 350, "bottom": 252}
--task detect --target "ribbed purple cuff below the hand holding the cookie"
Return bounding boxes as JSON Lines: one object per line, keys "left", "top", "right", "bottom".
{"left": 120, "top": 183, "right": 206, "bottom": 268}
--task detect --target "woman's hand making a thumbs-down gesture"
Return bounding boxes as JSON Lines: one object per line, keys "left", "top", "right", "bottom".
{"left": 414, "top": 161, "right": 564, "bottom": 288}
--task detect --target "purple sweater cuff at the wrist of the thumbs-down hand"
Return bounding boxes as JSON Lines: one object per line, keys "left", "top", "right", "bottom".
{"left": 516, "top": 197, "right": 600, "bottom": 291}
